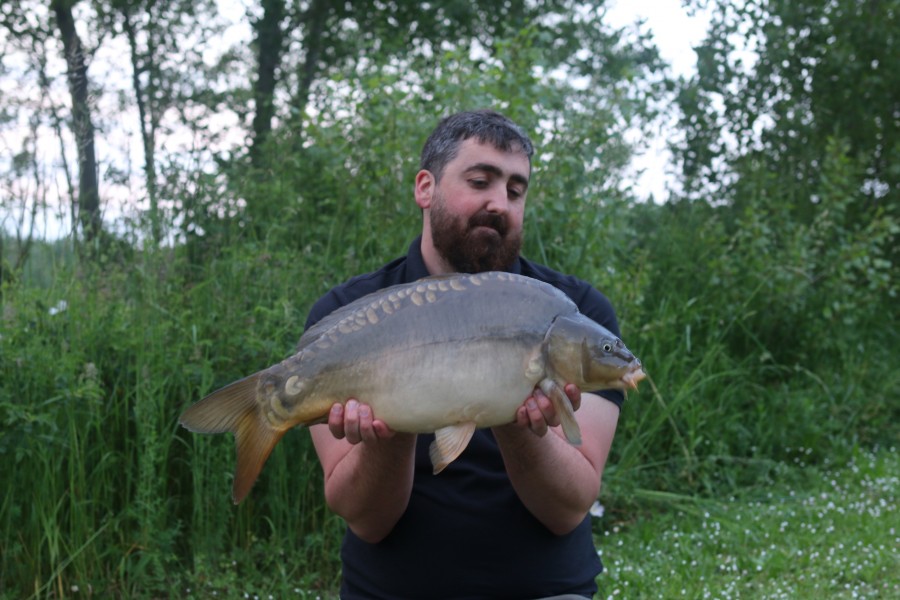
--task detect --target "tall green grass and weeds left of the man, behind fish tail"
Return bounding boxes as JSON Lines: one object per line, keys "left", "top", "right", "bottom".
{"left": 0, "top": 247, "right": 339, "bottom": 597}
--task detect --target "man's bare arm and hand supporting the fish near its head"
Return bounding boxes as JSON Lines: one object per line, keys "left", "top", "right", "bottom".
{"left": 493, "top": 385, "right": 619, "bottom": 535}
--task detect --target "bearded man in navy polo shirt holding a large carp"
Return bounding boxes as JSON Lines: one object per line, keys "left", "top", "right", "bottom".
{"left": 307, "top": 111, "right": 623, "bottom": 598}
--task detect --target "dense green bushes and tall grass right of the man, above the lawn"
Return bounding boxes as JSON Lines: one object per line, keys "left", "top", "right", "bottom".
{"left": 609, "top": 136, "right": 900, "bottom": 493}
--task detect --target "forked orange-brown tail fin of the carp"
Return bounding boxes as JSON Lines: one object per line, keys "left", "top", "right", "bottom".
{"left": 179, "top": 374, "right": 284, "bottom": 504}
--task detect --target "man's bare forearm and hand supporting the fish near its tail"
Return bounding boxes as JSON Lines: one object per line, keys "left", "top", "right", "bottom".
{"left": 309, "top": 400, "right": 416, "bottom": 543}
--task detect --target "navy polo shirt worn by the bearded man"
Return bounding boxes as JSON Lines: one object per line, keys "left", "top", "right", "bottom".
{"left": 306, "top": 238, "right": 624, "bottom": 600}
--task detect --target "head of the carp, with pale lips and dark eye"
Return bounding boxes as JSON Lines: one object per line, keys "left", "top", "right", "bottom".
{"left": 545, "top": 314, "right": 646, "bottom": 390}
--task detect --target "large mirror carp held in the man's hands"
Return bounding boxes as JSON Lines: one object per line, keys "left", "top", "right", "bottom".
{"left": 179, "top": 272, "right": 646, "bottom": 504}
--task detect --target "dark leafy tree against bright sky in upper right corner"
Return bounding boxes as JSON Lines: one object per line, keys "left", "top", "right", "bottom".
{"left": 678, "top": 0, "right": 900, "bottom": 222}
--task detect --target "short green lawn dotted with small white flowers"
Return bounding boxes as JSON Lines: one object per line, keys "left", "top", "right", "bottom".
{"left": 597, "top": 448, "right": 900, "bottom": 599}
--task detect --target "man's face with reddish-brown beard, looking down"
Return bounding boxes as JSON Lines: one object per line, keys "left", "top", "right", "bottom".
{"left": 429, "top": 139, "right": 530, "bottom": 273}
